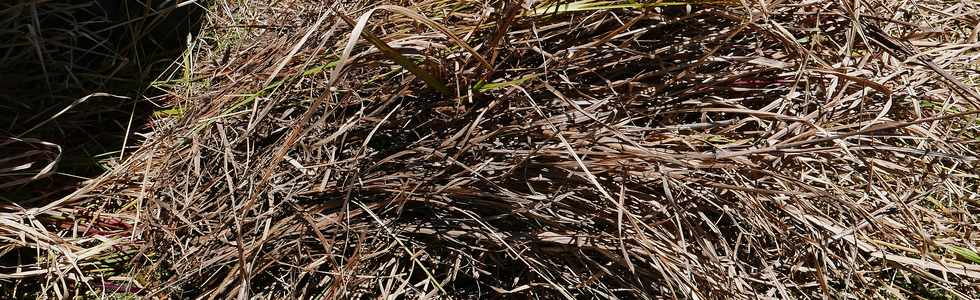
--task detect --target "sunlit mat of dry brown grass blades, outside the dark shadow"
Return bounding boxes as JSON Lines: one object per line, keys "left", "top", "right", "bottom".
{"left": 0, "top": 0, "right": 980, "bottom": 299}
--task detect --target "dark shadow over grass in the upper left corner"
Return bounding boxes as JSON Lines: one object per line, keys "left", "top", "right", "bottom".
{"left": 0, "top": 0, "right": 203, "bottom": 202}
